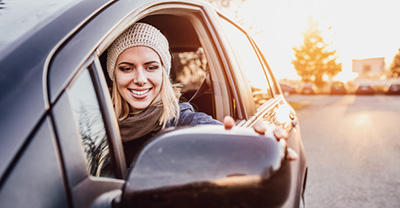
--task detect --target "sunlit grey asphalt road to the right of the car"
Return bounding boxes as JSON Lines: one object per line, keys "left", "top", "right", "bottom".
{"left": 287, "top": 95, "right": 400, "bottom": 208}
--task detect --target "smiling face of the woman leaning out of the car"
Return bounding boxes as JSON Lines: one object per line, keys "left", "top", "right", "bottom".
{"left": 114, "top": 46, "right": 163, "bottom": 109}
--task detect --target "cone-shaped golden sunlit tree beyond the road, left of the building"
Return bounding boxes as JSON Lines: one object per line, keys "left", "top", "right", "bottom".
{"left": 292, "top": 17, "right": 342, "bottom": 88}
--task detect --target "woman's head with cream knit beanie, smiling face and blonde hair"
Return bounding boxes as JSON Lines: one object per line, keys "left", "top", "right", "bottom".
{"left": 107, "top": 23, "right": 179, "bottom": 128}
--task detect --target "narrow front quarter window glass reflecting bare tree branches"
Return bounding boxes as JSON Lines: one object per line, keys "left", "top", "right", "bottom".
{"left": 68, "top": 70, "right": 114, "bottom": 177}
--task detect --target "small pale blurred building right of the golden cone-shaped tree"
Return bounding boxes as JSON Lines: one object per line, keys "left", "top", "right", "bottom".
{"left": 353, "top": 57, "right": 385, "bottom": 77}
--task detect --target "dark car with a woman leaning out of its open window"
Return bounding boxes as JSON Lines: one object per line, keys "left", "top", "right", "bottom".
{"left": 0, "top": 0, "right": 308, "bottom": 208}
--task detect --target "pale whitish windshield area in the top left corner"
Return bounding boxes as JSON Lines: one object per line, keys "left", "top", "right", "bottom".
{"left": 0, "top": 0, "right": 82, "bottom": 51}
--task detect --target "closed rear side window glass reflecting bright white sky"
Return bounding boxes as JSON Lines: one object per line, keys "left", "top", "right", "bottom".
{"left": 221, "top": 19, "right": 272, "bottom": 108}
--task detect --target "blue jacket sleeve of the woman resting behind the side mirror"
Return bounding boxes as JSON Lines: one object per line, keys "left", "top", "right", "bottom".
{"left": 177, "top": 102, "right": 222, "bottom": 126}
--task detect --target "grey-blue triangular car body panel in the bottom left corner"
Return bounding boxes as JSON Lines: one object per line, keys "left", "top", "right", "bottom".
{"left": 0, "top": 118, "right": 69, "bottom": 208}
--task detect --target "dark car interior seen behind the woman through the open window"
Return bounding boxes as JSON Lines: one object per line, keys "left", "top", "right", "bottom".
{"left": 100, "top": 14, "right": 216, "bottom": 118}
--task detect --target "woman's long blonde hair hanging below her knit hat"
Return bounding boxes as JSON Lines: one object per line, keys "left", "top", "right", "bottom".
{"left": 112, "top": 66, "right": 181, "bottom": 129}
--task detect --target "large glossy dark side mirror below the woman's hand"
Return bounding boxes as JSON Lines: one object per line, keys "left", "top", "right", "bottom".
{"left": 121, "top": 126, "right": 290, "bottom": 207}
